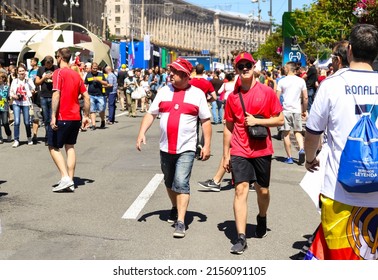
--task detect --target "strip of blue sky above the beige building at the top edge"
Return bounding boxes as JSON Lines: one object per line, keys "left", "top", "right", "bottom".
{"left": 185, "top": 0, "right": 316, "bottom": 23}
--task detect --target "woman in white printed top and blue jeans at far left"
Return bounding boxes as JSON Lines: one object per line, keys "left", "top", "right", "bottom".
{"left": 9, "top": 65, "right": 35, "bottom": 148}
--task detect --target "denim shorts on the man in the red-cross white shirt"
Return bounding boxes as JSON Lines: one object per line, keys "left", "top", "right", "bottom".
{"left": 160, "top": 151, "right": 195, "bottom": 194}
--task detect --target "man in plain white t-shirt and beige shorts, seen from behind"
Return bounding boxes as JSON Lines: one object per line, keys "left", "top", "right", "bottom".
{"left": 277, "top": 61, "right": 308, "bottom": 164}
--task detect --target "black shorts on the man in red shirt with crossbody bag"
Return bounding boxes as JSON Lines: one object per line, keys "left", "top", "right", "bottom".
{"left": 231, "top": 155, "right": 272, "bottom": 188}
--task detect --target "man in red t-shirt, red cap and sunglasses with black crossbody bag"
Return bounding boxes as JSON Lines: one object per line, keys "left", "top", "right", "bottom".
{"left": 223, "top": 53, "right": 284, "bottom": 254}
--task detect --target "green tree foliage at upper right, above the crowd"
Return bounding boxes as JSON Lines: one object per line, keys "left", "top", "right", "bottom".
{"left": 255, "top": 0, "right": 378, "bottom": 64}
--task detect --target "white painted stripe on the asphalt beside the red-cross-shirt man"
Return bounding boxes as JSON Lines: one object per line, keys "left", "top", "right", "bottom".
{"left": 122, "top": 174, "right": 164, "bottom": 219}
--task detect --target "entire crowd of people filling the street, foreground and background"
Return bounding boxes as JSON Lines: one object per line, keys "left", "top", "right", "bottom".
{"left": 0, "top": 25, "right": 378, "bottom": 259}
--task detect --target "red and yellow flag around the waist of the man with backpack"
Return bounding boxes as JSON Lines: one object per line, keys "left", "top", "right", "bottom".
{"left": 305, "top": 196, "right": 378, "bottom": 260}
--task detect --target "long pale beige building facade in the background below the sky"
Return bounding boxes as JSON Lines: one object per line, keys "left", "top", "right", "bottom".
{"left": 102, "top": 0, "right": 270, "bottom": 64}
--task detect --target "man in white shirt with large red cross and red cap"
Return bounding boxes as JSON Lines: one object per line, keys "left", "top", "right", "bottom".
{"left": 136, "top": 58, "right": 211, "bottom": 238}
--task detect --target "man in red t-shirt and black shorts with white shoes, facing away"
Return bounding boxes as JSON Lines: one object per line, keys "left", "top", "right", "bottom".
{"left": 47, "top": 48, "right": 90, "bottom": 192}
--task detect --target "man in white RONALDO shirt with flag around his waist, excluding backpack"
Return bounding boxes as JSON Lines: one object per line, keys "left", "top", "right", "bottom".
{"left": 305, "top": 24, "right": 378, "bottom": 260}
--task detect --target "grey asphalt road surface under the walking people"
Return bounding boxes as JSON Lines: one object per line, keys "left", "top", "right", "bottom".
{"left": 0, "top": 109, "right": 320, "bottom": 260}
